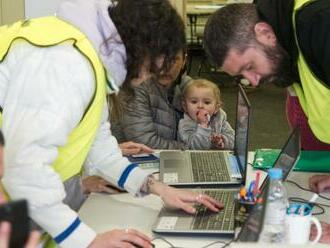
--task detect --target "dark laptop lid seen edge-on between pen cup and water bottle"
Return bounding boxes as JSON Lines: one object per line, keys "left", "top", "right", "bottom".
{"left": 235, "top": 180, "right": 269, "bottom": 242}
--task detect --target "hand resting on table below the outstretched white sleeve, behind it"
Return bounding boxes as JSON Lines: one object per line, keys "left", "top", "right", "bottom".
{"left": 82, "top": 176, "right": 123, "bottom": 194}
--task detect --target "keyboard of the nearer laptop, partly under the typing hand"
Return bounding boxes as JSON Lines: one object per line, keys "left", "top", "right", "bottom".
{"left": 192, "top": 190, "right": 235, "bottom": 231}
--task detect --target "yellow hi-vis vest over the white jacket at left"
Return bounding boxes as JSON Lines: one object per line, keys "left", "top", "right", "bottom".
{"left": 0, "top": 17, "right": 106, "bottom": 181}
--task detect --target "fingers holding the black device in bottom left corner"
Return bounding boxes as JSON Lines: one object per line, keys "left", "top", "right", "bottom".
{"left": 0, "top": 221, "right": 40, "bottom": 248}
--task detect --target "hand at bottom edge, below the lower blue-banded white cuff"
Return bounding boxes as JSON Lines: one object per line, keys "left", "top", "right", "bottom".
{"left": 88, "top": 229, "right": 152, "bottom": 248}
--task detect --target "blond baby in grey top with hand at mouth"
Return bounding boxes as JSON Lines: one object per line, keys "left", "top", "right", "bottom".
{"left": 178, "top": 79, "right": 235, "bottom": 150}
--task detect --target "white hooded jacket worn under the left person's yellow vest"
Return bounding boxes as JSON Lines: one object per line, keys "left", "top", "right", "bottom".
{"left": 0, "top": 0, "right": 148, "bottom": 248}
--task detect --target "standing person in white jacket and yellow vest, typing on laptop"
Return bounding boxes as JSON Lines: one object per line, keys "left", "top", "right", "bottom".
{"left": 0, "top": 0, "right": 222, "bottom": 248}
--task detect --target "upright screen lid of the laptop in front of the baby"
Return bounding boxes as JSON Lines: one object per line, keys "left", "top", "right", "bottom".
{"left": 234, "top": 84, "right": 251, "bottom": 185}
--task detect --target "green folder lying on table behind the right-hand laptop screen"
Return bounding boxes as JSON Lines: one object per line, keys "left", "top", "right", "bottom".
{"left": 253, "top": 149, "right": 330, "bottom": 172}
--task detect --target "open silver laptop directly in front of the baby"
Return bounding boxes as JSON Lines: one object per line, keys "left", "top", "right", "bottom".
{"left": 159, "top": 85, "right": 251, "bottom": 186}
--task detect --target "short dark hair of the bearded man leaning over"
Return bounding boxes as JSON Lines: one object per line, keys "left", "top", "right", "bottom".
{"left": 204, "top": 3, "right": 260, "bottom": 67}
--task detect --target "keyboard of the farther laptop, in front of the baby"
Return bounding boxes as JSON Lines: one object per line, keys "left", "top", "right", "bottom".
{"left": 190, "top": 152, "right": 230, "bottom": 182}
